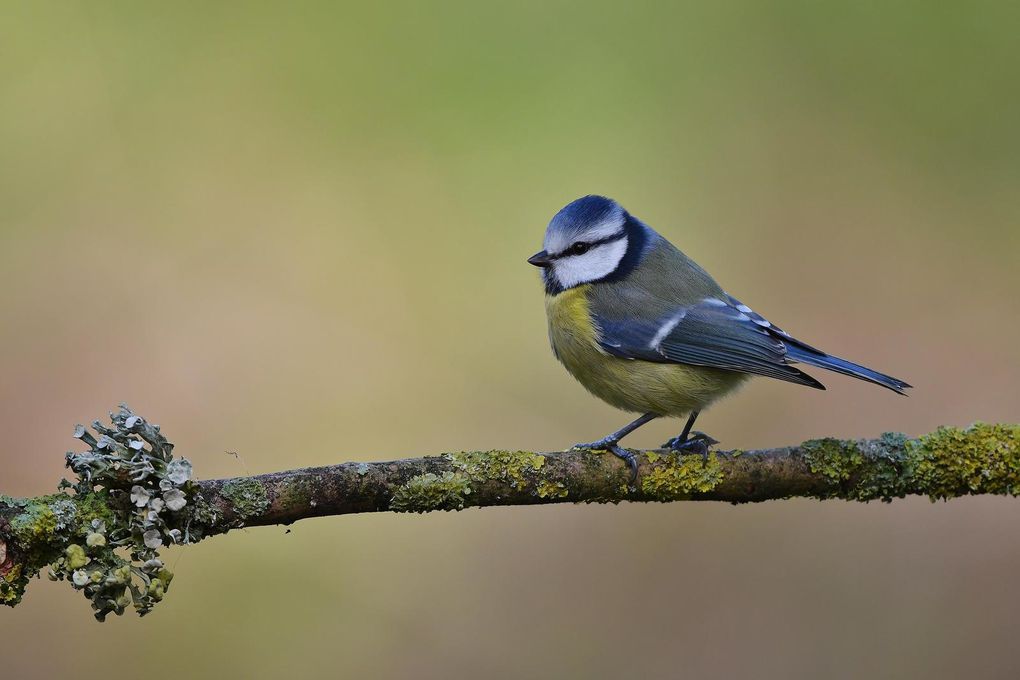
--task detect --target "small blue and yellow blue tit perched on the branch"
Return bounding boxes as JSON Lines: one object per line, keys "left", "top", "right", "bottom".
{"left": 527, "top": 195, "right": 911, "bottom": 480}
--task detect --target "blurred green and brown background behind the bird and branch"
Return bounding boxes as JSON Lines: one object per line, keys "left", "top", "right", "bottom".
{"left": 0, "top": 0, "right": 1020, "bottom": 680}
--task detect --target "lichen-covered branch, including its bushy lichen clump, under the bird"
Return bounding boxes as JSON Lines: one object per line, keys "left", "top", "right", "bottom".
{"left": 0, "top": 407, "right": 1020, "bottom": 620}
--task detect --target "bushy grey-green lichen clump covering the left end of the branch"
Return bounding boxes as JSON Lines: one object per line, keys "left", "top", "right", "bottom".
{"left": 0, "top": 406, "right": 193, "bottom": 621}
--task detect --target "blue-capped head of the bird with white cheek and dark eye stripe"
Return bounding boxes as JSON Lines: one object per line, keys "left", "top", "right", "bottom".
{"left": 527, "top": 196, "right": 646, "bottom": 293}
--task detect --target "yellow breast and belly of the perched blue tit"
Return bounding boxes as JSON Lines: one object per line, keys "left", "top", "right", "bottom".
{"left": 546, "top": 285, "right": 748, "bottom": 416}
